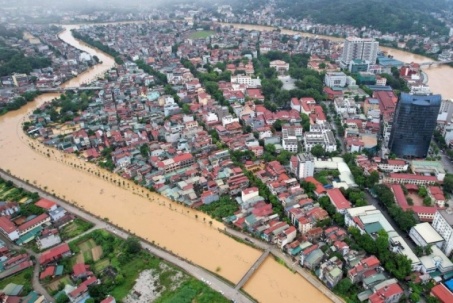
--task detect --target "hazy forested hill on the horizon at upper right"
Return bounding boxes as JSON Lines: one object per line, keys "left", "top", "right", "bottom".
{"left": 270, "top": 0, "right": 452, "bottom": 36}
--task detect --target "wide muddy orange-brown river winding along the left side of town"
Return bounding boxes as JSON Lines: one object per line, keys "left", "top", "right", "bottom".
{"left": 0, "top": 26, "right": 330, "bottom": 303}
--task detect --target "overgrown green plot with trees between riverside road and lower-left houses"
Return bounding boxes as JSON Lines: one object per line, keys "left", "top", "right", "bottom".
{"left": 62, "top": 230, "right": 227, "bottom": 302}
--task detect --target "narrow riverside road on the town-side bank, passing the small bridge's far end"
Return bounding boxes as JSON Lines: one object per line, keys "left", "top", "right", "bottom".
{"left": 224, "top": 227, "right": 344, "bottom": 303}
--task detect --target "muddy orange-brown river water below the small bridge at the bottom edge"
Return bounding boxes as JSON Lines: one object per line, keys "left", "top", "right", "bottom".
{"left": 244, "top": 257, "right": 329, "bottom": 303}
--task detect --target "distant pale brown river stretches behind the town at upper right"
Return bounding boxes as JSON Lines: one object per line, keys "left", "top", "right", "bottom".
{"left": 226, "top": 23, "right": 453, "bottom": 99}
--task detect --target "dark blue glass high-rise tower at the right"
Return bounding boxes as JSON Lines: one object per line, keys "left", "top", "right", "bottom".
{"left": 388, "top": 93, "right": 442, "bottom": 158}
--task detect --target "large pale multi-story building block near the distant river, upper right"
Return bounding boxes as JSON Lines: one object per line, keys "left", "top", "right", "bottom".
{"left": 341, "top": 37, "right": 379, "bottom": 67}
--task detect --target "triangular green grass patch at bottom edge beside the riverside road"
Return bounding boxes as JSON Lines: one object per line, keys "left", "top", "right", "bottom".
{"left": 154, "top": 278, "right": 230, "bottom": 303}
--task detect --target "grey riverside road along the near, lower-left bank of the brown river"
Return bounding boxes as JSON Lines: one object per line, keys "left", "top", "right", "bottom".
{"left": 0, "top": 170, "right": 254, "bottom": 303}
